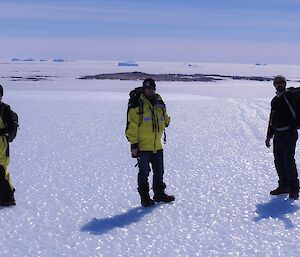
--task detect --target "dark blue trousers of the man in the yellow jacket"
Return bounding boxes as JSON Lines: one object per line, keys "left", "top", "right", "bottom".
{"left": 138, "top": 150, "right": 164, "bottom": 188}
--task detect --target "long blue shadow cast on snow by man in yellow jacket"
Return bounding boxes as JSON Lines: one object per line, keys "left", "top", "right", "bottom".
{"left": 81, "top": 204, "right": 158, "bottom": 235}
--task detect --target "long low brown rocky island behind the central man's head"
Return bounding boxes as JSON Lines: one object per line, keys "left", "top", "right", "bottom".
{"left": 79, "top": 71, "right": 273, "bottom": 82}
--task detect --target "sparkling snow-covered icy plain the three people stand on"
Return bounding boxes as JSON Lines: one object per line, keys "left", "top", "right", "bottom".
{"left": 0, "top": 61, "right": 300, "bottom": 257}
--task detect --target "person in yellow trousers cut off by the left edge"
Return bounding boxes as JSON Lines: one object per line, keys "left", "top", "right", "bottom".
{"left": 0, "top": 85, "right": 16, "bottom": 206}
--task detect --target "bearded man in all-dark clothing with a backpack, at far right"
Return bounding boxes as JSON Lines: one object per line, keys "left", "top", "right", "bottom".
{"left": 265, "top": 76, "right": 299, "bottom": 200}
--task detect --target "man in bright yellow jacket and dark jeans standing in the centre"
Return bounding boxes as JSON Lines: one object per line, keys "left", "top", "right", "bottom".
{"left": 125, "top": 78, "right": 175, "bottom": 207}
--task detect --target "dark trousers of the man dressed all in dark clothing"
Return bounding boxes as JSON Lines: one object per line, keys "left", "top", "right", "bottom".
{"left": 273, "top": 130, "right": 299, "bottom": 191}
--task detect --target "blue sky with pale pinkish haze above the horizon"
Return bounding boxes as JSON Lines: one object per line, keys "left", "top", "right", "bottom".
{"left": 0, "top": 0, "right": 300, "bottom": 64}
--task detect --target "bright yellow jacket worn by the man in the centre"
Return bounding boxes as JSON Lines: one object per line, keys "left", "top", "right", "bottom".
{"left": 125, "top": 94, "right": 170, "bottom": 153}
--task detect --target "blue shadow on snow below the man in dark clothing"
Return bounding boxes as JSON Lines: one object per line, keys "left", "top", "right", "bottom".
{"left": 253, "top": 196, "right": 300, "bottom": 229}
